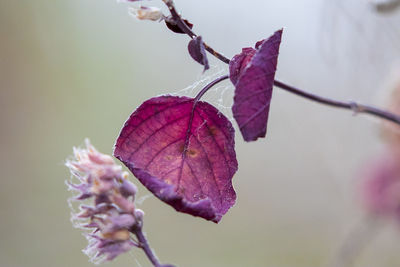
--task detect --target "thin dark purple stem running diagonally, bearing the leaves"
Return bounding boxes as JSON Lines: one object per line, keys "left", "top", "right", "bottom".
{"left": 163, "top": 0, "right": 400, "bottom": 125}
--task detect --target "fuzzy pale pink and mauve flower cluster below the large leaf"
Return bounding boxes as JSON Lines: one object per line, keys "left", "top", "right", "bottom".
{"left": 66, "top": 140, "right": 143, "bottom": 263}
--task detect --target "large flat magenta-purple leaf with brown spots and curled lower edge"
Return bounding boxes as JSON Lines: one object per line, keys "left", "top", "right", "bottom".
{"left": 114, "top": 96, "right": 237, "bottom": 222}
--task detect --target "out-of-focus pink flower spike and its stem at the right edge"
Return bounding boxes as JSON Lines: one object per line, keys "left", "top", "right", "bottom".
{"left": 329, "top": 75, "right": 400, "bottom": 267}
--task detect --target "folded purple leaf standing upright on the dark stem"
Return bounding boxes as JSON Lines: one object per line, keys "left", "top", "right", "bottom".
{"left": 229, "top": 30, "right": 282, "bottom": 142}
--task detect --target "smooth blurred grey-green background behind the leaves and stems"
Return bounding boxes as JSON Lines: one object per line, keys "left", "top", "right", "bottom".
{"left": 0, "top": 0, "right": 400, "bottom": 267}
